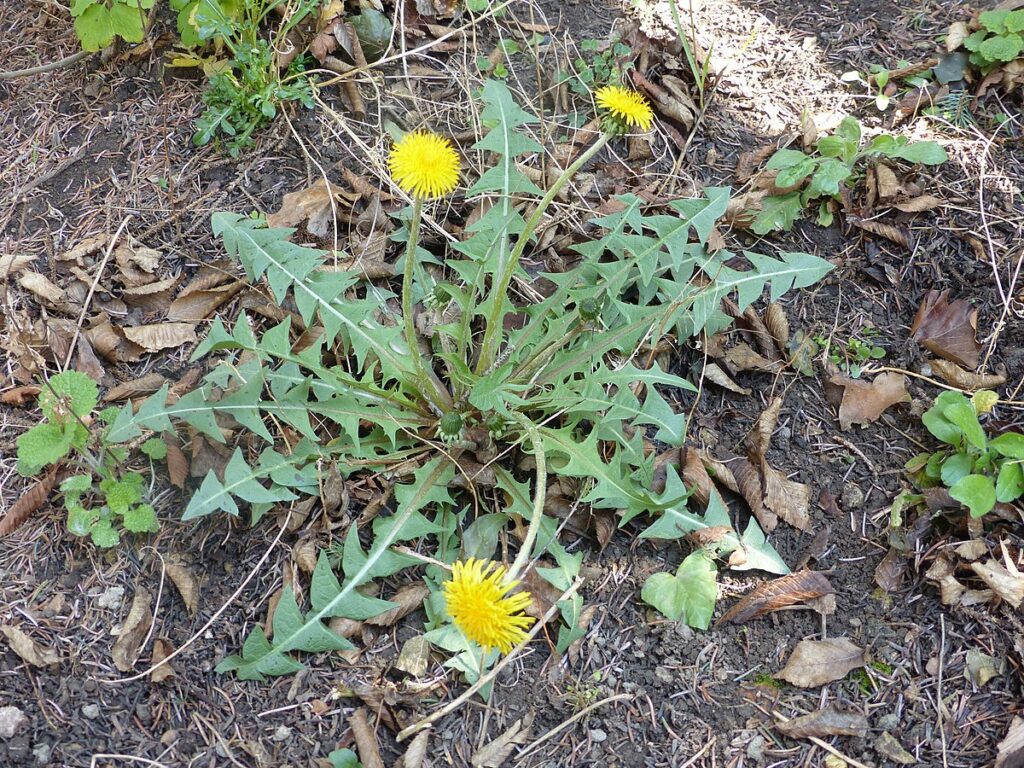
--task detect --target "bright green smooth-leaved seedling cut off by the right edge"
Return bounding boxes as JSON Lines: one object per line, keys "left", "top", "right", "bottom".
{"left": 906, "top": 390, "right": 1024, "bottom": 517}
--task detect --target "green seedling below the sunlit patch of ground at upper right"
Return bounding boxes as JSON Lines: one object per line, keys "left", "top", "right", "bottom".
{"left": 751, "top": 117, "right": 947, "bottom": 234}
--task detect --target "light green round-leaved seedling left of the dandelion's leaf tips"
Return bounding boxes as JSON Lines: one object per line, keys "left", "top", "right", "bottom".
{"left": 17, "top": 371, "right": 160, "bottom": 547}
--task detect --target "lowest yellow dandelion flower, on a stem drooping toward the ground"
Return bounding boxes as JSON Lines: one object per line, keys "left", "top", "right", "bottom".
{"left": 443, "top": 557, "right": 534, "bottom": 653}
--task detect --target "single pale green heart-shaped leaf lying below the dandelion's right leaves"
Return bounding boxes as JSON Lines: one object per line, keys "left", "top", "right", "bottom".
{"left": 640, "top": 550, "right": 718, "bottom": 630}
